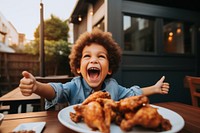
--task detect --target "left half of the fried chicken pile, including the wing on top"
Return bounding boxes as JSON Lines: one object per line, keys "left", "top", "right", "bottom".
{"left": 70, "top": 91, "right": 112, "bottom": 133}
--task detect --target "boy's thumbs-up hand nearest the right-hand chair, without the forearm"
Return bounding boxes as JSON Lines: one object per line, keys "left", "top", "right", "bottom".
{"left": 154, "top": 76, "right": 169, "bottom": 94}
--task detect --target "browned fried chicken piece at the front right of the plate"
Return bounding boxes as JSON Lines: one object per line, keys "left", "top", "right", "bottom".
{"left": 120, "top": 105, "right": 172, "bottom": 131}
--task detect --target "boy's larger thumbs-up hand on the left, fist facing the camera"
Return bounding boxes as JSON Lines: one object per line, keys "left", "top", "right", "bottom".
{"left": 19, "top": 71, "right": 37, "bottom": 96}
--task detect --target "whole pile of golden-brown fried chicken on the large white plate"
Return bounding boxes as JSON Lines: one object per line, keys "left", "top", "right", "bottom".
{"left": 70, "top": 91, "right": 172, "bottom": 133}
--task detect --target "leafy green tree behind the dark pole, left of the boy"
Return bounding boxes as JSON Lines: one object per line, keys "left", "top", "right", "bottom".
{"left": 24, "top": 15, "right": 71, "bottom": 74}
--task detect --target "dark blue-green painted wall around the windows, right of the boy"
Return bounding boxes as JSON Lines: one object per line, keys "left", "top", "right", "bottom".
{"left": 107, "top": 0, "right": 200, "bottom": 104}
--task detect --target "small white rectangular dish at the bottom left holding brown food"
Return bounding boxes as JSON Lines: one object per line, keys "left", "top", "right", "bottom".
{"left": 13, "top": 122, "right": 46, "bottom": 133}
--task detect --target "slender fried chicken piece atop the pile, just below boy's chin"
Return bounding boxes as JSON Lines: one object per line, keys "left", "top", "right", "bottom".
{"left": 82, "top": 91, "right": 111, "bottom": 105}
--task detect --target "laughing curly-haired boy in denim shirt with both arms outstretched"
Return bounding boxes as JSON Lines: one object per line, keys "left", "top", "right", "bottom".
{"left": 19, "top": 29, "right": 169, "bottom": 109}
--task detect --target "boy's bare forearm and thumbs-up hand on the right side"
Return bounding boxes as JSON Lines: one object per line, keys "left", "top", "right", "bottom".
{"left": 142, "top": 76, "right": 169, "bottom": 96}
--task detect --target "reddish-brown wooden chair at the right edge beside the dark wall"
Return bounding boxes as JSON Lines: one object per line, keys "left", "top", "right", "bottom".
{"left": 185, "top": 76, "right": 200, "bottom": 107}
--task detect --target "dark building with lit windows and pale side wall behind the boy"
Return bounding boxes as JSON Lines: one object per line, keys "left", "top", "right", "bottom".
{"left": 70, "top": 0, "right": 200, "bottom": 104}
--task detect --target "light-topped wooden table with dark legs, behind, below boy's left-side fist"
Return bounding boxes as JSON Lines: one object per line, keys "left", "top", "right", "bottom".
{"left": 0, "top": 87, "right": 41, "bottom": 113}
